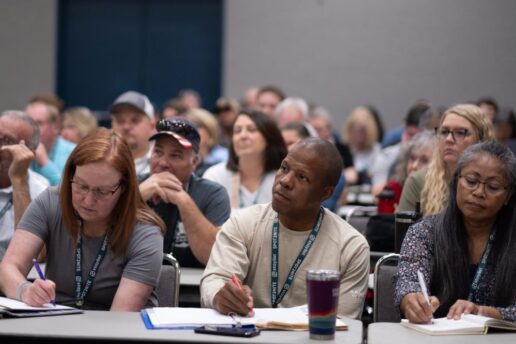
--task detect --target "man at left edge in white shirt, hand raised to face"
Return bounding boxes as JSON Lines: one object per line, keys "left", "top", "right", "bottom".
{"left": 0, "top": 111, "right": 49, "bottom": 260}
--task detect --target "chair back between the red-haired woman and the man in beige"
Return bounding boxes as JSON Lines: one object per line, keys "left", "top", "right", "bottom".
{"left": 156, "top": 253, "right": 180, "bottom": 307}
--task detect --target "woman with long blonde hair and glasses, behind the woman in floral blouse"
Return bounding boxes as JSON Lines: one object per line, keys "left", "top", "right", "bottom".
{"left": 397, "top": 104, "right": 494, "bottom": 215}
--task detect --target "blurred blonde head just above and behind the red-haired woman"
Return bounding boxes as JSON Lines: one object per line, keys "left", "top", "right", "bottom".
{"left": 61, "top": 107, "right": 98, "bottom": 143}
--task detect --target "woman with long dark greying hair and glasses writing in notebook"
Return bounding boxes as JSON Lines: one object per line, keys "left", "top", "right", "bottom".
{"left": 395, "top": 141, "right": 516, "bottom": 323}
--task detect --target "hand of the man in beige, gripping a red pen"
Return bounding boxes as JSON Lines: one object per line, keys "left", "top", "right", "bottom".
{"left": 213, "top": 281, "right": 254, "bottom": 316}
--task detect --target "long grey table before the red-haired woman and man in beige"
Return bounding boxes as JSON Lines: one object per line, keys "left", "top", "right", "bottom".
{"left": 0, "top": 311, "right": 362, "bottom": 344}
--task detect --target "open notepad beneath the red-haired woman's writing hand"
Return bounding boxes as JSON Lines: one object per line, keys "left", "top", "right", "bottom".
{"left": 0, "top": 297, "right": 82, "bottom": 318}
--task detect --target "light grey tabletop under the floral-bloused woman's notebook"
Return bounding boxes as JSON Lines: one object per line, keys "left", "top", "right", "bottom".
{"left": 367, "top": 322, "right": 516, "bottom": 344}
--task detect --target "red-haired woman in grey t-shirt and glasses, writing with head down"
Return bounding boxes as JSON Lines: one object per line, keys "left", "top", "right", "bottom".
{"left": 0, "top": 128, "right": 164, "bottom": 311}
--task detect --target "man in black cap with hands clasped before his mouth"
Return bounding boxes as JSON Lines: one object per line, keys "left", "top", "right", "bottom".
{"left": 140, "top": 117, "right": 231, "bottom": 267}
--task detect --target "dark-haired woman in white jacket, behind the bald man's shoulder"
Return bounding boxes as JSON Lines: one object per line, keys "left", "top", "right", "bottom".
{"left": 203, "top": 111, "right": 287, "bottom": 209}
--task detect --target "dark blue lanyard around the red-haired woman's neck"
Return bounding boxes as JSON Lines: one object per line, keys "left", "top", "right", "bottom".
{"left": 75, "top": 235, "right": 108, "bottom": 308}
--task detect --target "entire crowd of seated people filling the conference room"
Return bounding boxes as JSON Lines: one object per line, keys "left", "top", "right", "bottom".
{"left": 0, "top": 85, "right": 516, "bottom": 328}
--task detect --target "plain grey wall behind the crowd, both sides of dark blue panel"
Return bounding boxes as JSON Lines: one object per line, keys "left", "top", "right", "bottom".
{"left": 0, "top": 0, "right": 516, "bottom": 128}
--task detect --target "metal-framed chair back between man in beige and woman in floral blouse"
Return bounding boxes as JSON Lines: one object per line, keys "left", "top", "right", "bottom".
{"left": 373, "top": 253, "right": 401, "bottom": 322}
